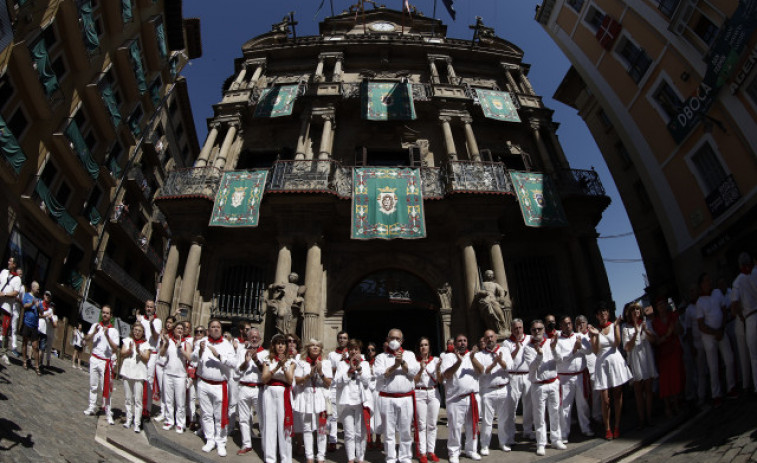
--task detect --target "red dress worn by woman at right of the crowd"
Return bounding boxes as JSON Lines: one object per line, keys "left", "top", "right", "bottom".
{"left": 652, "top": 312, "right": 686, "bottom": 398}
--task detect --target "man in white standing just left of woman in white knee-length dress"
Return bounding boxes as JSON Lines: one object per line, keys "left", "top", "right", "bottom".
{"left": 556, "top": 315, "right": 594, "bottom": 444}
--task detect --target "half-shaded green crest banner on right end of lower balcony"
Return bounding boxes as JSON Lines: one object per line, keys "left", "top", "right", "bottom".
{"left": 510, "top": 172, "right": 568, "bottom": 227}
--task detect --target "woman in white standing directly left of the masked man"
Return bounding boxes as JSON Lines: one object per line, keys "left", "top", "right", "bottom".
{"left": 334, "top": 339, "right": 373, "bottom": 463}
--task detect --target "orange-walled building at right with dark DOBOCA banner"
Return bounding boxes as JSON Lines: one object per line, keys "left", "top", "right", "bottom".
{"left": 536, "top": 0, "right": 757, "bottom": 296}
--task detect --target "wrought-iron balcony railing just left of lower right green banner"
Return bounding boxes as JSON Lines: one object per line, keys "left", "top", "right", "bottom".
{"left": 446, "top": 161, "right": 513, "bottom": 193}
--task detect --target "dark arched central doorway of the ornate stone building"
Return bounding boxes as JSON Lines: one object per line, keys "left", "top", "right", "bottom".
{"left": 342, "top": 269, "right": 443, "bottom": 354}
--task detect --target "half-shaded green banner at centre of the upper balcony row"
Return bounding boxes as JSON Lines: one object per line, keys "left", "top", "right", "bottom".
{"left": 362, "top": 82, "right": 416, "bottom": 121}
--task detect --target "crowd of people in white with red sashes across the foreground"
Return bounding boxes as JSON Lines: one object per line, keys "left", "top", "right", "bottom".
{"left": 0, "top": 254, "right": 757, "bottom": 463}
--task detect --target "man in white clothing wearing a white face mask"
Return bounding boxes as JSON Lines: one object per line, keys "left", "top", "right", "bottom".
{"left": 373, "top": 328, "right": 420, "bottom": 463}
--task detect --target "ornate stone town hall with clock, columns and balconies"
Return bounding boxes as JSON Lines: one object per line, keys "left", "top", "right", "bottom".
{"left": 156, "top": 8, "right": 612, "bottom": 348}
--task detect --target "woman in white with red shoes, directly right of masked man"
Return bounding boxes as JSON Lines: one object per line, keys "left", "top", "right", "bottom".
{"left": 413, "top": 337, "right": 442, "bottom": 463}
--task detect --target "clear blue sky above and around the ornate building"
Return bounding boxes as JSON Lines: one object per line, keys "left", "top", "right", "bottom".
{"left": 183, "top": 0, "right": 645, "bottom": 314}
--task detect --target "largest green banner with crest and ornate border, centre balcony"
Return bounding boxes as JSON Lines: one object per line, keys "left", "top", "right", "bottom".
{"left": 351, "top": 167, "right": 426, "bottom": 240}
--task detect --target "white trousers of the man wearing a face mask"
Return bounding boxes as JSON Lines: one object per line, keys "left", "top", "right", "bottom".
{"left": 381, "top": 396, "right": 413, "bottom": 463}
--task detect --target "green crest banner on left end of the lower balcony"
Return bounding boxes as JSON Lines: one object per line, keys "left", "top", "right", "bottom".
{"left": 210, "top": 170, "right": 268, "bottom": 227}
